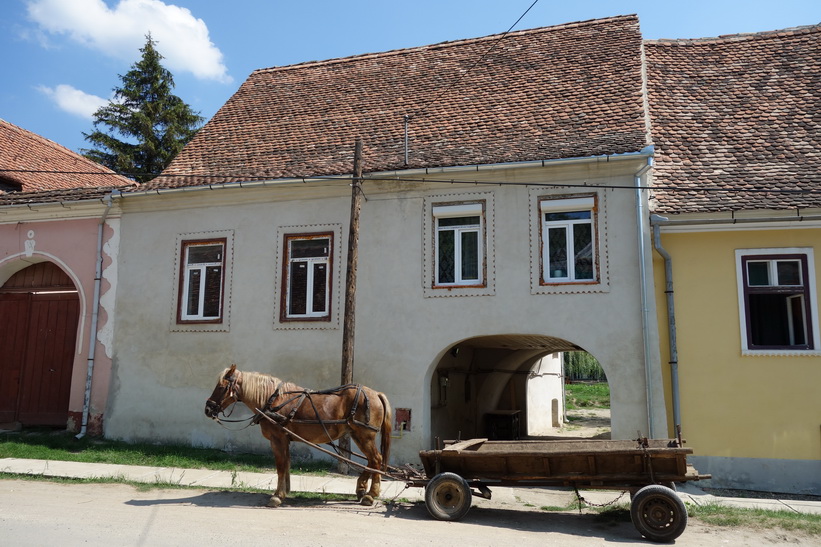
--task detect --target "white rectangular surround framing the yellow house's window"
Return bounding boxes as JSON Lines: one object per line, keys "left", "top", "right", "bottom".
{"left": 735, "top": 247, "right": 821, "bottom": 357}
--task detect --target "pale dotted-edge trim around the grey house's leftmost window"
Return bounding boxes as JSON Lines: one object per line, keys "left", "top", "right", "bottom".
{"left": 171, "top": 230, "right": 234, "bottom": 332}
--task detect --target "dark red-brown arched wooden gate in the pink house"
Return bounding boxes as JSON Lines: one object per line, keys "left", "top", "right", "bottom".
{"left": 0, "top": 262, "right": 80, "bottom": 427}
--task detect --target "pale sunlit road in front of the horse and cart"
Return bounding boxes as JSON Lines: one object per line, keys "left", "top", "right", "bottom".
{"left": 0, "top": 479, "right": 817, "bottom": 547}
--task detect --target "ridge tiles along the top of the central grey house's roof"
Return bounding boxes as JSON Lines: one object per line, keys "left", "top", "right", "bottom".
{"left": 251, "top": 14, "right": 638, "bottom": 76}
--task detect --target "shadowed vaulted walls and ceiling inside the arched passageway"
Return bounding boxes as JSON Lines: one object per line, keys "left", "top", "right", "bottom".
{"left": 430, "top": 334, "right": 608, "bottom": 444}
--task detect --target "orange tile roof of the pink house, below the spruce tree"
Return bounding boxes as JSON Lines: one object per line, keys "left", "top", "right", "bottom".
{"left": 0, "top": 119, "right": 133, "bottom": 198}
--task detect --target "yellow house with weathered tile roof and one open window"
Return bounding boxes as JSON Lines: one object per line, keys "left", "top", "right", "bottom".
{"left": 645, "top": 26, "right": 821, "bottom": 494}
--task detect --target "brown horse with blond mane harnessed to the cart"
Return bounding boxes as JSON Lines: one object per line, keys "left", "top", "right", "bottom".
{"left": 205, "top": 365, "right": 392, "bottom": 507}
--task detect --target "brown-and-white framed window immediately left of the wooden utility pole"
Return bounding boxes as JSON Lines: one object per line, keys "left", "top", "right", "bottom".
{"left": 281, "top": 233, "right": 333, "bottom": 321}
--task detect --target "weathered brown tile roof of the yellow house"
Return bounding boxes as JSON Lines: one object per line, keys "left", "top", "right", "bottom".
{"left": 645, "top": 25, "right": 821, "bottom": 214}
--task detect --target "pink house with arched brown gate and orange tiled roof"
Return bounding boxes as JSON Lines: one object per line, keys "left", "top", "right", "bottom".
{"left": 0, "top": 120, "right": 131, "bottom": 434}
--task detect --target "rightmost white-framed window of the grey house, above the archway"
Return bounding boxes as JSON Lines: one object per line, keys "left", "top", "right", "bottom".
{"left": 539, "top": 196, "right": 598, "bottom": 283}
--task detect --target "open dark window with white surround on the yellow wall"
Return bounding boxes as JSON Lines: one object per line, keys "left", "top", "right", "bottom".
{"left": 736, "top": 249, "right": 818, "bottom": 352}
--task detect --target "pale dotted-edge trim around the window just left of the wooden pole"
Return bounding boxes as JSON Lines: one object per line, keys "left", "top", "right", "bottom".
{"left": 273, "top": 224, "right": 345, "bottom": 330}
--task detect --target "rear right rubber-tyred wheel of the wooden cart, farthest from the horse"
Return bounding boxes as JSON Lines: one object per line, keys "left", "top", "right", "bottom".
{"left": 630, "top": 484, "right": 687, "bottom": 543}
